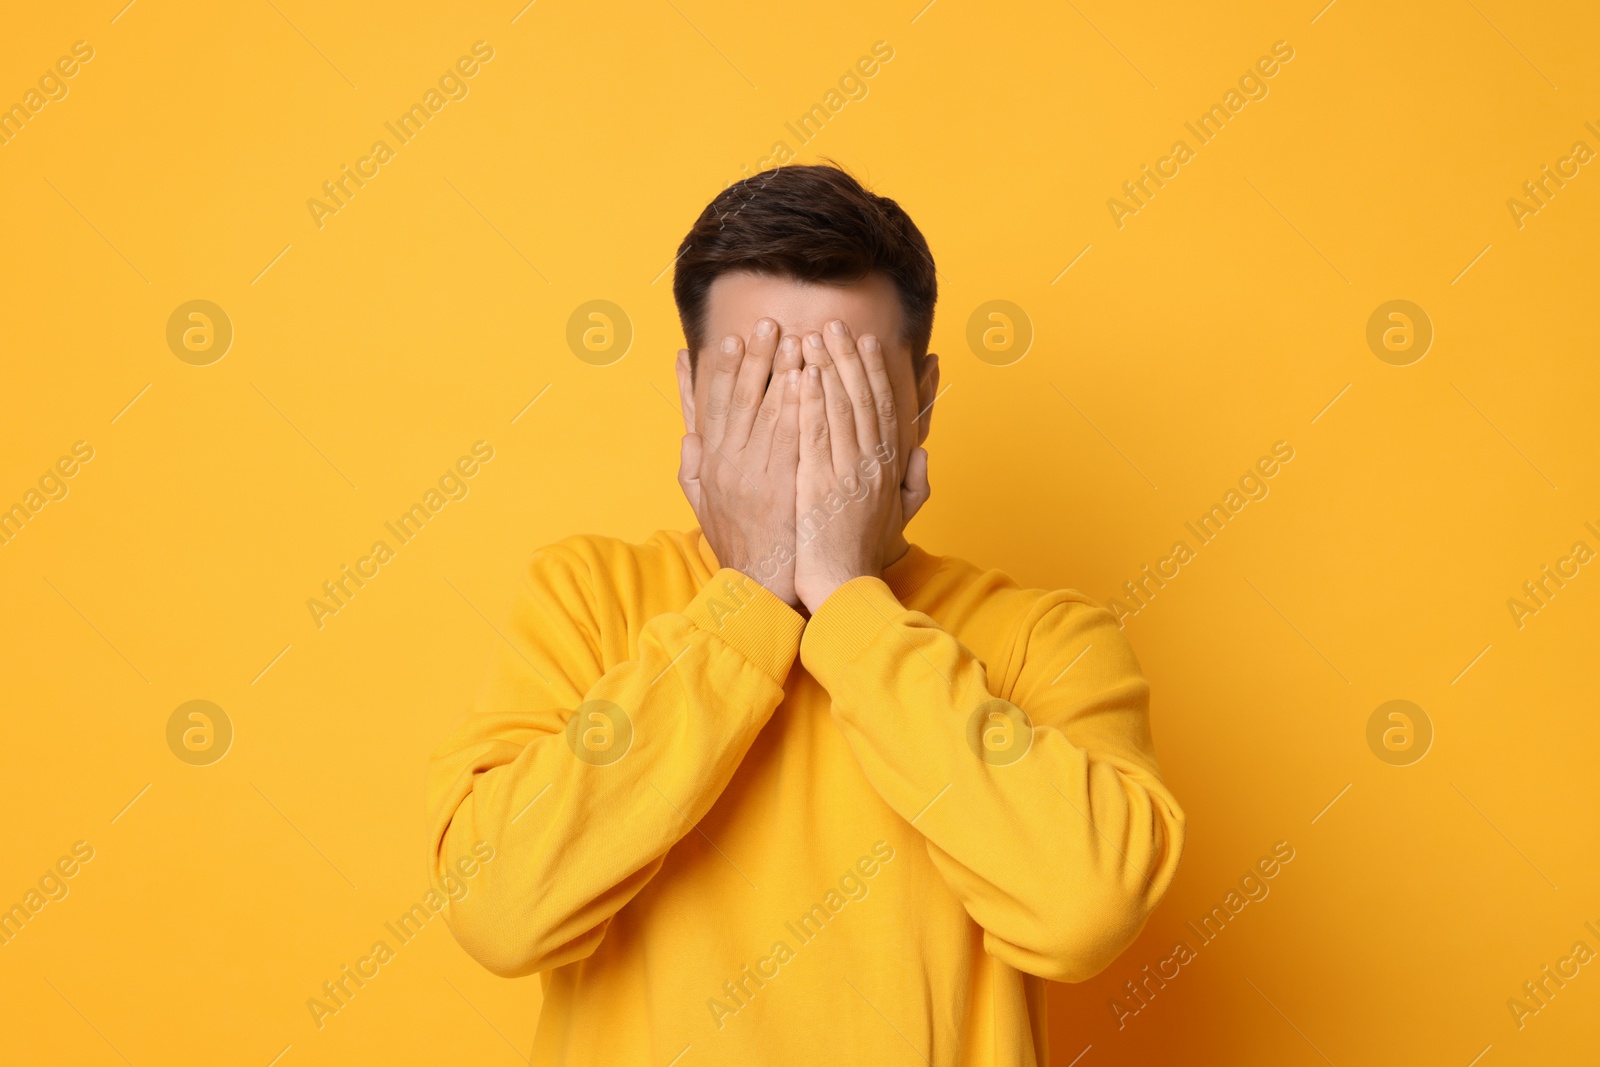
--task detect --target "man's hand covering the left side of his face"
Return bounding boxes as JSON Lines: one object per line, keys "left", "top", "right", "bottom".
{"left": 678, "top": 318, "right": 802, "bottom": 606}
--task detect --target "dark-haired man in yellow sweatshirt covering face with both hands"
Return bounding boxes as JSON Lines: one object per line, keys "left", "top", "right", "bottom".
{"left": 429, "top": 166, "right": 1184, "bottom": 1067}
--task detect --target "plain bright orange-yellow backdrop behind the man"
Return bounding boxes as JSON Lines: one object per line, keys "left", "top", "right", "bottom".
{"left": 0, "top": 0, "right": 1600, "bottom": 1067}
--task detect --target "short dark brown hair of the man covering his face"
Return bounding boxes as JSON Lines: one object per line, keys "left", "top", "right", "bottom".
{"left": 672, "top": 165, "right": 939, "bottom": 382}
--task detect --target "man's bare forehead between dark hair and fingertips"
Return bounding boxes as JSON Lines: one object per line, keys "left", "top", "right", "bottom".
{"left": 706, "top": 270, "right": 901, "bottom": 337}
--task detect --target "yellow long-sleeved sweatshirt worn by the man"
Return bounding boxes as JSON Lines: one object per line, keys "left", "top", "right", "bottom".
{"left": 427, "top": 530, "right": 1184, "bottom": 1067}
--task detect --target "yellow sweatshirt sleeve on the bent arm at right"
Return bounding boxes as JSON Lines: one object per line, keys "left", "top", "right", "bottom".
{"left": 800, "top": 577, "right": 1184, "bottom": 982}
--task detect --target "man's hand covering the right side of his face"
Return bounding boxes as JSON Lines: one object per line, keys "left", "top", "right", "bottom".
{"left": 794, "top": 320, "right": 930, "bottom": 613}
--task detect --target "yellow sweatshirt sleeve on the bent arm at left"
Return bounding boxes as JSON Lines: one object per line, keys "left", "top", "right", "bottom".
{"left": 427, "top": 556, "right": 805, "bottom": 976}
